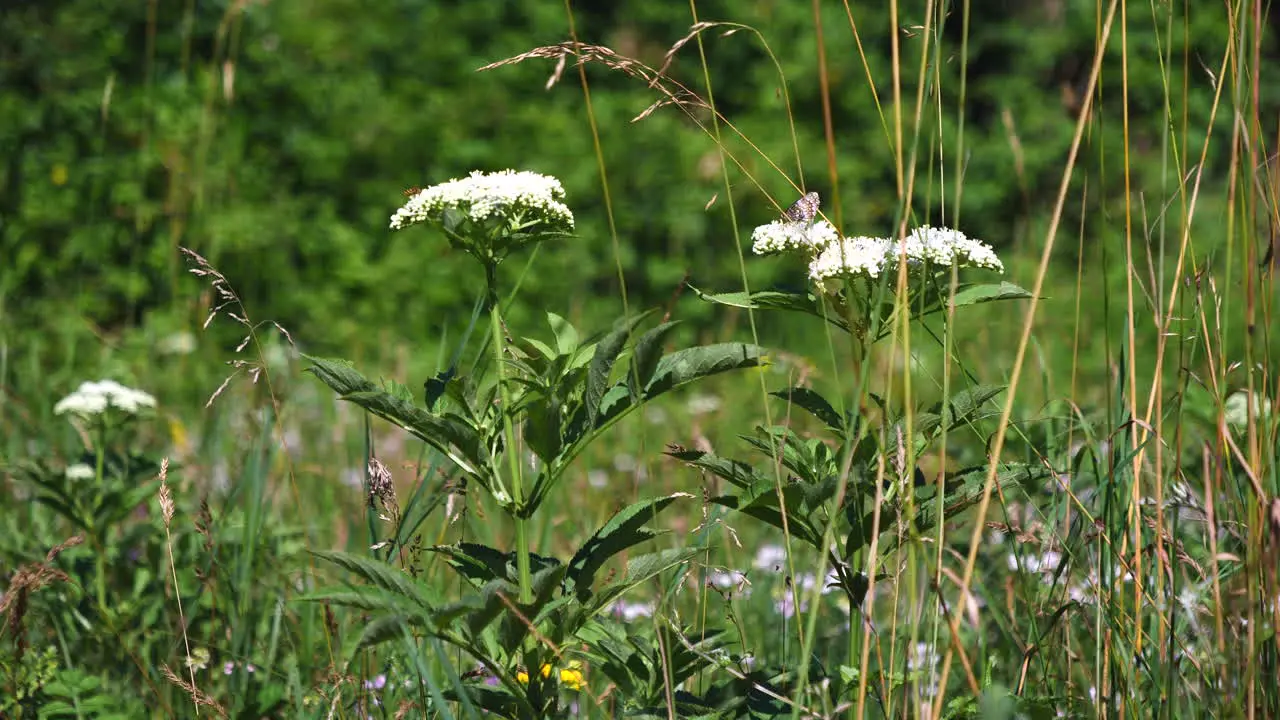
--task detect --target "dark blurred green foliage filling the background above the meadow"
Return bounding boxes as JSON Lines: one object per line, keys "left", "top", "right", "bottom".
{"left": 0, "top": 0, "right": 1277, "bottom": 356}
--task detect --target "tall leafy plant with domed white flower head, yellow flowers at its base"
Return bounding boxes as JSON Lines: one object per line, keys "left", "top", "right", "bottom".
{"left": 300, "top": 170, "right": 762, "bottom": 717}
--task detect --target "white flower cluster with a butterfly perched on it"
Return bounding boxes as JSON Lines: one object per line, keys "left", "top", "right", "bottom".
{"left": 751, "top": 215, "right": 1005, "bottom": 283}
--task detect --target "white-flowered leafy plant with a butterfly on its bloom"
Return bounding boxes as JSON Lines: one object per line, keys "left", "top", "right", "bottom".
{"left": 668, "top": 193, "right": 1044, "bottom": 707}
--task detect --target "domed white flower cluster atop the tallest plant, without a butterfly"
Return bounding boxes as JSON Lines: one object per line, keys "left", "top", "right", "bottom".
{"left": 392, "top": 170, "right": 573, "bottom": 231}
